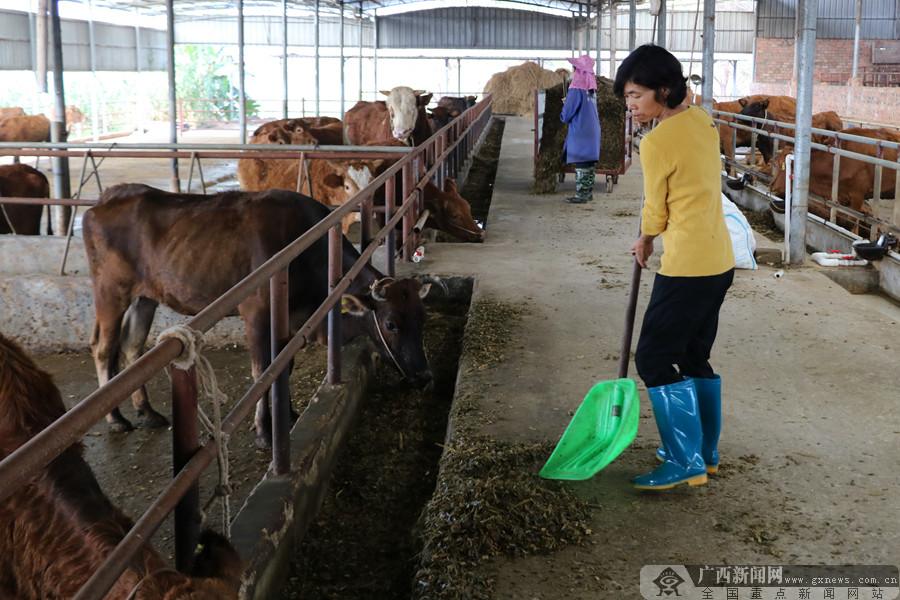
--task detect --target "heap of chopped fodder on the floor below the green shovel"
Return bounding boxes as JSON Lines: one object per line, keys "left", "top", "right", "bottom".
{"left": 413, "top": 436, "right": 591, "bottom": 600}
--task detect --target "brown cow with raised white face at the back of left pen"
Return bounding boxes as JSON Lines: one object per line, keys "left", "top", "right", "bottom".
{"left": 344, "top": 86, "right": 432, "bottom": 146}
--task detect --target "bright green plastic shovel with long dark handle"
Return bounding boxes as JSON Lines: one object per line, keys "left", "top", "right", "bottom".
{"left": 540, "top": 255, "right": 641, "bottom": 480}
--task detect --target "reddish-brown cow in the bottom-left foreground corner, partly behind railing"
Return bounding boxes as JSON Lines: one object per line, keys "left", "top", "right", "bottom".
{"left": 0, "top": 335, "right": 242, "bottom": 600}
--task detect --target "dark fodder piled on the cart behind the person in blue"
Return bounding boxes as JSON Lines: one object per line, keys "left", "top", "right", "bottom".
{"left": 534, "top": 77, "right": 625, "bottom": 194}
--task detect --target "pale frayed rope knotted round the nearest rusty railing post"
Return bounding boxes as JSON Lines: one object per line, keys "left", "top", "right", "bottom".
{"left": 156, "top": 325, "right": 232, "bottom": 537}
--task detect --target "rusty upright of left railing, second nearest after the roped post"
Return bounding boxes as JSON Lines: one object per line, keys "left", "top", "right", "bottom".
{"left": 269, "top": 269, "right": 291, "bottom": 475}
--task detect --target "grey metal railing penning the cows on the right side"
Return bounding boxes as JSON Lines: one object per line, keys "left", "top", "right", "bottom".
{"left": 713, "top": 110, "right": 900, "bottom": 234}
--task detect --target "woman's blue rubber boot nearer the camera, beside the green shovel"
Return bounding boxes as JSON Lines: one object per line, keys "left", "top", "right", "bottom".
{"left": 631, "top": 379, "right": 707, "bottom": 490}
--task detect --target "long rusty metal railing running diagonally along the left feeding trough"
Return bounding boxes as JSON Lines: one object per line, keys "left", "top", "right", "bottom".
{"left": 0, "top": 97, "right": 491, "bottom": 600}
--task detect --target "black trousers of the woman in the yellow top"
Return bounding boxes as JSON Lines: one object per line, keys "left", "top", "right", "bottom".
{"left": 634, "top": 269, "right": 734, "bottom": 388}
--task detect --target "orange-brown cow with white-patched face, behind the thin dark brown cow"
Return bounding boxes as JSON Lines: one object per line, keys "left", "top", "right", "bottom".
{"left": 238, "top": 119, "right": 382, "bottom": 234}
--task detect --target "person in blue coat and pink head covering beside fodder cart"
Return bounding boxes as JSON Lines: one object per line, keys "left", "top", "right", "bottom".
{"left": 560, "top": 54, "right": 600, "bottom": 204}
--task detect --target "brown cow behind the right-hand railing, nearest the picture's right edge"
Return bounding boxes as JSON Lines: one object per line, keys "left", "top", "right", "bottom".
{"left": 769, "top": 127, "right": 900, "bottom": 214}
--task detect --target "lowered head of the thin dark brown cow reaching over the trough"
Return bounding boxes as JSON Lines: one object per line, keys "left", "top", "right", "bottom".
{"left": 341, "top": 277, "right": 447, "bottom": 387}
